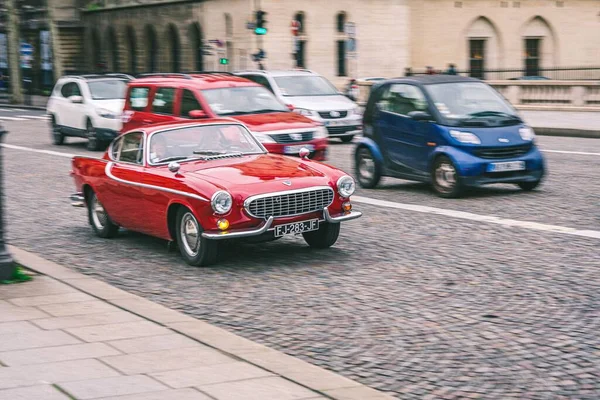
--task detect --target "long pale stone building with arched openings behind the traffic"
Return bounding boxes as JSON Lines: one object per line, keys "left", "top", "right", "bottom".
{"left": 0, "top": 0, "right": 600, "bottom": 89}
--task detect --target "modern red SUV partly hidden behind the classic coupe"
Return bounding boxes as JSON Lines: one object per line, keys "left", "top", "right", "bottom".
{"left": 122, "top": 72, "right": 327, "bottom": 161}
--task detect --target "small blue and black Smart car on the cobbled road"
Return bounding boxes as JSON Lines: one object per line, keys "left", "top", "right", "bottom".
{"left": 355, "top": 75, "right": 544, "bottom": 197}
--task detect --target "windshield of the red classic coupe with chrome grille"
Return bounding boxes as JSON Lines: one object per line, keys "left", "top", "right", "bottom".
{"left": 149, "top": 124, "right": 265, "bottom": 164}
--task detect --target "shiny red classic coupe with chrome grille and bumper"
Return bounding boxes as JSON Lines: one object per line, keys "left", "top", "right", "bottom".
{"left": 71, "top": 119, "right": 361, "bottom": 266}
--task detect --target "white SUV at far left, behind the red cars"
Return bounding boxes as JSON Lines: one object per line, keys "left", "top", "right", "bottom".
{"left": 46, "top": 74, "right": 133, "bottom": 150}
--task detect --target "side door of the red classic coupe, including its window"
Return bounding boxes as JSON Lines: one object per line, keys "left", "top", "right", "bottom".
{"left": 98, "top": 131, "right": 146, "bottom": 232}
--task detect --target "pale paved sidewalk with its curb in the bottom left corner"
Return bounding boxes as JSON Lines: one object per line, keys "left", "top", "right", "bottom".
{"left": 0, "top": 246, "right": 393, "bottom": 400}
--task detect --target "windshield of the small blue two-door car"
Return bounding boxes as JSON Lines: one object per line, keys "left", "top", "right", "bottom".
{"left": 426, "top": 82, "right": 522, "bottom": 126}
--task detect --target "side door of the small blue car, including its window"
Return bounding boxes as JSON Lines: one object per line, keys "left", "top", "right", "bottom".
{"left": 377, "top": 83, "right": 432, "bottom": 174}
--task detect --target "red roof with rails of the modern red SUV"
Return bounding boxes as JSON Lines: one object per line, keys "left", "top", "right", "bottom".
{"left": 129, "top": 72, "right": 261, "bottom": 89}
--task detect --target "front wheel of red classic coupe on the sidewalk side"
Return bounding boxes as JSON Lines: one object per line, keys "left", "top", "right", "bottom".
{"left": 177, "top": 207, "right": 218, "bottom": 267}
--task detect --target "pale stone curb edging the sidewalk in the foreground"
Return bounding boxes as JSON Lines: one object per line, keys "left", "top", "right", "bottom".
{"left": 8, "top": 245, "right": 395, "bottom": 400}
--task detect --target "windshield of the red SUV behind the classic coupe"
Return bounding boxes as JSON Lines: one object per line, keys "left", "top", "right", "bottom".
{"left": 202, "top": 86, "right": 290, "bottom": 116}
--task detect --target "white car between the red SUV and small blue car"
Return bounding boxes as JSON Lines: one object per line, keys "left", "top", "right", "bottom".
{"left": 236, "top": 70, "right": 362, "bottom": 142}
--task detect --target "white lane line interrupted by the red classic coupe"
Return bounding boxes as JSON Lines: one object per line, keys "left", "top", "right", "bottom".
{"left": 0, "top": 144, "right": 600, "bottom": 239}
